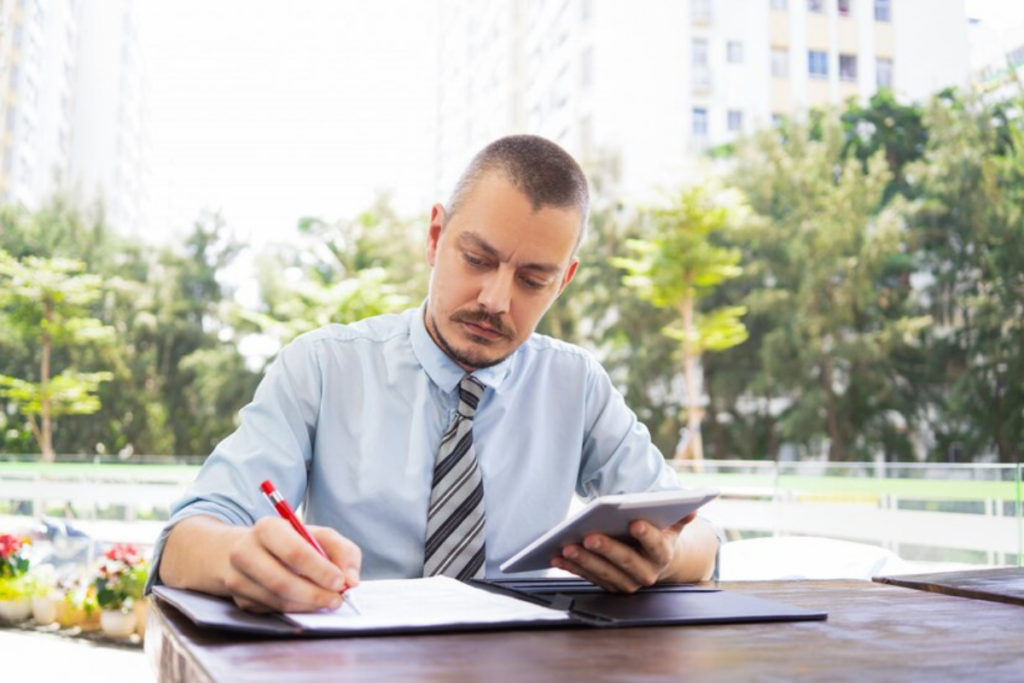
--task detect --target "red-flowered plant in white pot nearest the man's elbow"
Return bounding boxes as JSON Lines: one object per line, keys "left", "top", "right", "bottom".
{"left": 93, "top": 544, "right": 148, "bottom": 638}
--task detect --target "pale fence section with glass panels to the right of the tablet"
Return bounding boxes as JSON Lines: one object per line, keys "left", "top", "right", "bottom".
{"left": 675, "top": 461, "right": 1024, "bottom": 565}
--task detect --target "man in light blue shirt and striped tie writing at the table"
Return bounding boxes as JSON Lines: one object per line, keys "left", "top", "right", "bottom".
{"left": 154, "top": 135, "right": 717, "bottom": 611}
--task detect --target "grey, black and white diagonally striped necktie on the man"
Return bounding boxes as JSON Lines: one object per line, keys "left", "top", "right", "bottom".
{"left": 423, "top": 375, "right": 486, "bottom": 581}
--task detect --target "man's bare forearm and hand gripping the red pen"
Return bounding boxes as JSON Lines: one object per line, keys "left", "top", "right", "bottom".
{"left": 159, "top": 515, "right": 361, "bottom": 611}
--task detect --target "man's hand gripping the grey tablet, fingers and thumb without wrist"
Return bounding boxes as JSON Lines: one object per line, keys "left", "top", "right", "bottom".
{"left": 551, "top": 513, "right": 696, "bottom": 593}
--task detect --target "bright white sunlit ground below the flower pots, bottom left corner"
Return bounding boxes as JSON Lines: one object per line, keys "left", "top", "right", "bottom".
{"left": 0, "top": 630, "right": 155, "bottom": 683}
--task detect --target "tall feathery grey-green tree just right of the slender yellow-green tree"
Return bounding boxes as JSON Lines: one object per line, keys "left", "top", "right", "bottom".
{"left": 723, "top": 114, "right": 930, "bottom": 460}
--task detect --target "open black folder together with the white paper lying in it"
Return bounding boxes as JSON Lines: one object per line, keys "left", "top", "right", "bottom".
{"left": 154, "top": 577, "right": 825, "bottom": 636}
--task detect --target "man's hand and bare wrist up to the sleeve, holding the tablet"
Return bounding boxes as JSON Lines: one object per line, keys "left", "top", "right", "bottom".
{"left": 552, "top": 513, "right": 718, "bottom": 593}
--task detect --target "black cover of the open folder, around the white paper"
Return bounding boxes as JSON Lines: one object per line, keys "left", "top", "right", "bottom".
{"left": 154, "top": 580, "right": 826, "bottom": 637}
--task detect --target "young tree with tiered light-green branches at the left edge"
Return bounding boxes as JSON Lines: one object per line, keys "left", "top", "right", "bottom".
{"left": 0, "top": 251, "right": 114, "bottom": 462}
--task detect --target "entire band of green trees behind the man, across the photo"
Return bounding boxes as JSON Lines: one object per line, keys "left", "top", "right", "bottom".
{"left": 0, "top": 91, "right": 1024, "bottom": 462}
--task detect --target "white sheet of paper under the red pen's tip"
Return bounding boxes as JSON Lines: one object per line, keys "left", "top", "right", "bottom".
{"left": 285, "top": 577, "right": 571, "bottom": 631}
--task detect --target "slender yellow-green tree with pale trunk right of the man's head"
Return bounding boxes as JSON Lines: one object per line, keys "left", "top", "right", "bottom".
{"left": 613, "top": 185, "right": 748, "bottom": 461}
